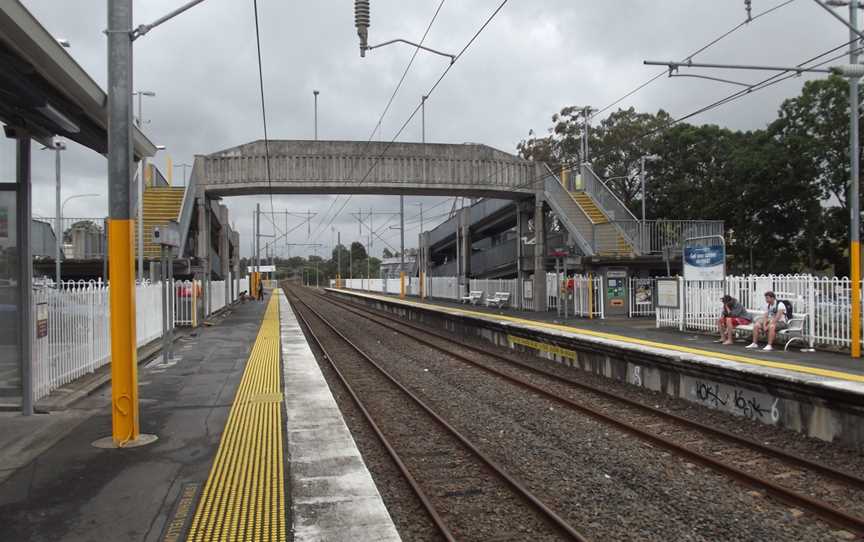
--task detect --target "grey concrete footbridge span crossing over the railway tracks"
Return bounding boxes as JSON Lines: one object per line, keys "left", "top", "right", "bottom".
{"left": 192, "top": 140, "right": 549, "bottom": 199}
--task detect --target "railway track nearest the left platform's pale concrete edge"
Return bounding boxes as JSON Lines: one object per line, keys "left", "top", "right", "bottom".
{"left": 286, "top": 288, "right": 587, "bottom": 541}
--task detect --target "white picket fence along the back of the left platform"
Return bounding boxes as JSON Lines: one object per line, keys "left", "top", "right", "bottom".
{"left": 32, "top": 279, "right": 248, "bottom": 400}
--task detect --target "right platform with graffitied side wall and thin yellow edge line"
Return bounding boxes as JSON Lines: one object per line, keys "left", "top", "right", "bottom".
{"left": 325, "top": 289, "right": 864, "bottom": 449}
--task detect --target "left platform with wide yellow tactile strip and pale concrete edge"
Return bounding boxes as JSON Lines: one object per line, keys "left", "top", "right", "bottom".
{"left": 0, "top": 289, "right": 399, "bottom": 542}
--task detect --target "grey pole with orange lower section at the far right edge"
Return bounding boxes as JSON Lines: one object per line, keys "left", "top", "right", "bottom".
{"left": 849, "top": 0, "right": 861, "bottom": 358}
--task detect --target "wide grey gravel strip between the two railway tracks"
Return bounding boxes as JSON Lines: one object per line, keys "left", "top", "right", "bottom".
{"left": 306, "top": 292, "right": 847, "bottom": 540}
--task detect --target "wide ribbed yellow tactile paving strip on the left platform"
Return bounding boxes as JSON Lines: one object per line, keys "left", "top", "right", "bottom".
{"left": 186, "top": 296, "right": 286, "bottom": 542}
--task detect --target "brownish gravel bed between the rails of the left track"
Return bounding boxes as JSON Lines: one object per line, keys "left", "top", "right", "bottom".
{"left": 290, "top": 294, "right": 564, "bottom": 540}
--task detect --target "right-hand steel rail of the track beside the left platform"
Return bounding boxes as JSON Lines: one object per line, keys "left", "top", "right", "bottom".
{"left": 292, "top": 286, "right": 588, "bottom": 542}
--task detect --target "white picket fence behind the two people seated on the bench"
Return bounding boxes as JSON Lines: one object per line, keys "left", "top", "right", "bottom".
{"left": 656, "top": 275, "right": 862, "bottom": 348}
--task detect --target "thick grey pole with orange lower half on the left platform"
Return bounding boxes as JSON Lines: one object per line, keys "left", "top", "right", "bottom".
{"left": 93, "top": 0, "right": 156, "bottom": 448}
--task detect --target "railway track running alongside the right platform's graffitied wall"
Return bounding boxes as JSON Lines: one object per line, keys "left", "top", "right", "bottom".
{"left": 314, "top": 286, "right": 864, "bottom": 537}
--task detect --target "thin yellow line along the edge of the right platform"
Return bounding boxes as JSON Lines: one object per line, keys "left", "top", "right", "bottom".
{"left": 336, "top": 292, "right": 864, "bottom": 382}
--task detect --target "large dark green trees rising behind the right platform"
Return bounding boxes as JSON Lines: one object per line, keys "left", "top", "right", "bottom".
{"left": 518, "top": 76, "right": 861, "bottom": 274}
